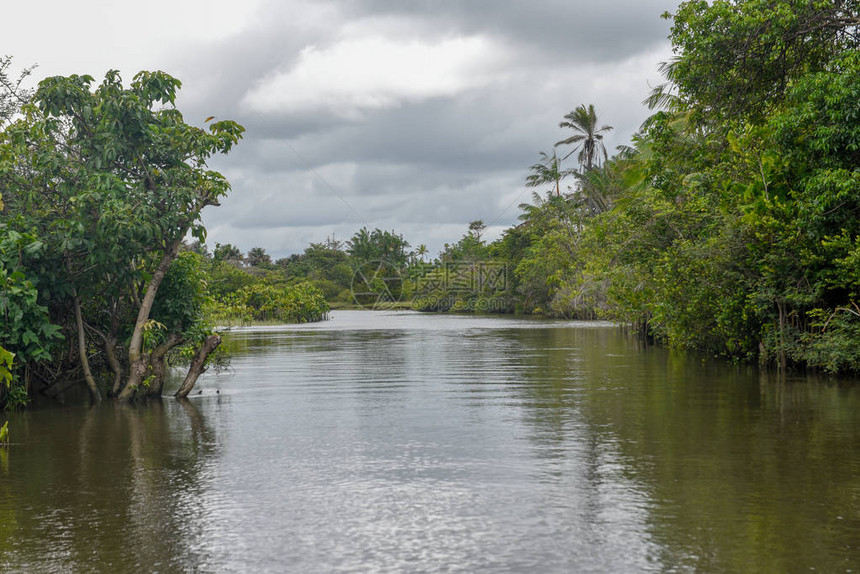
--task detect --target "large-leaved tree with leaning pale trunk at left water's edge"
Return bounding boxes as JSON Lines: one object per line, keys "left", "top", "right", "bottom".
{"left": 0, "top": 71, "right": 244, "bottom": 401}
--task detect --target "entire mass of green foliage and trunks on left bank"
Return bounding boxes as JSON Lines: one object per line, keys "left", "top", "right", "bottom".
{"left": 0, "top": 67, "right": 249, "bottom": 403}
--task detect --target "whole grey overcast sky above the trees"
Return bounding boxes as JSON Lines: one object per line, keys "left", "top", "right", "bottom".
{"left": 5, "top": 0, "right": 677, "bottom": 258}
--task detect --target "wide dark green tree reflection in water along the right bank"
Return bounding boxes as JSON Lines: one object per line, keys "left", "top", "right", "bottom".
{"left": 508, "top": 331, "right": 860, "bottom": 571}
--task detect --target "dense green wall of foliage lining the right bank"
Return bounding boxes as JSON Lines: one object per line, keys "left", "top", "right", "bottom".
{"left": 518, "top": 0, "right": 860, "bottom": 372}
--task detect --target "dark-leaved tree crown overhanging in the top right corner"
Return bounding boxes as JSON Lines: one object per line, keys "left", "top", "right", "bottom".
{"left": 664, "top": 0, "right": 860, "bottom": 125}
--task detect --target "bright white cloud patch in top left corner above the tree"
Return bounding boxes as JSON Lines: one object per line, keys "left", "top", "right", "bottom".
{"left": 0, "top": 0, "right": 265, "bottom": 80}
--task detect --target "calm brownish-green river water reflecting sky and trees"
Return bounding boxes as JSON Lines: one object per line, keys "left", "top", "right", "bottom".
{"left": 0, "top": 311, "right": 860, "bottom": 574}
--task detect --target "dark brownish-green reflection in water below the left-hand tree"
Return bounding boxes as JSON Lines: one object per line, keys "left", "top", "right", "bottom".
{"left": 0, "top": 401, "right": 222, "bottom": 572}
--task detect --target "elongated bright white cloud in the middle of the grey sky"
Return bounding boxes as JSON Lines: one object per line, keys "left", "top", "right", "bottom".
{"left": 242, "top": 36, "right": 508, "bottom": 117}
